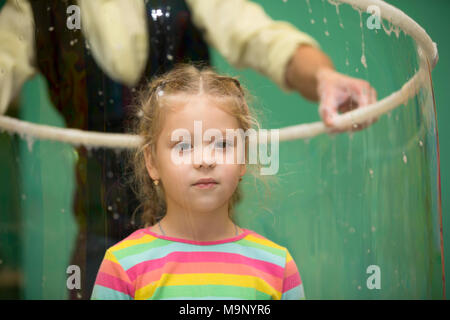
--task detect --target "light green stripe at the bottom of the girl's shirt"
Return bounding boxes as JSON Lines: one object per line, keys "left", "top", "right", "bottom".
{"left": 150, "top": 285, "right": 272, "bottom": 300}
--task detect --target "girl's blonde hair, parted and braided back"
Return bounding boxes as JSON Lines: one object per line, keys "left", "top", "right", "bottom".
{"left": 128, "top": 63, "right": 259, "bottom": 227}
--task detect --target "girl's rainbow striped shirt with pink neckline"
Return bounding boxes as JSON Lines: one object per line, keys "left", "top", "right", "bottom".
{"left": 91, "top": 228, "right": 305, "bottom": 300}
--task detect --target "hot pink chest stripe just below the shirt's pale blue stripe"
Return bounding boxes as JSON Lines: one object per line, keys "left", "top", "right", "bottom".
{"left": 126, "top": 251, "right": 284, "bottom": 281}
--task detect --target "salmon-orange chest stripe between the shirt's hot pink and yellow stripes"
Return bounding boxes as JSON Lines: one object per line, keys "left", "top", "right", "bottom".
{"left": 134, "top": 262, "right": 283, "bottom": 291}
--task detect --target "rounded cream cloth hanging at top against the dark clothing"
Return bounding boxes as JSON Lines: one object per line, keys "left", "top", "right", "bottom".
{"left": 78, "top": 0, "right": 149, "bottom": 86}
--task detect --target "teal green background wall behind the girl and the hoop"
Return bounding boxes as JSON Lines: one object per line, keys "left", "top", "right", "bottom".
{"left": 0, "top": 0, "right": 450, "bottom": 299}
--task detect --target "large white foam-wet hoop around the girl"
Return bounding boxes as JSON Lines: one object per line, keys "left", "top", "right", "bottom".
{"left": 0, "top": 0, "right": 438, "bottom": 148}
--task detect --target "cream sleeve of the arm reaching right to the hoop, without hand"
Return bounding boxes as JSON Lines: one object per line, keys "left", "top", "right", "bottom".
{"left": 187, "top": 0, "right": 320, "bottom": 92}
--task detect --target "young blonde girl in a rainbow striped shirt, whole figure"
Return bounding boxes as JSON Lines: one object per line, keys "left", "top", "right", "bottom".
{"left": 91, "top": 64, "right": 304, "bottom": 300}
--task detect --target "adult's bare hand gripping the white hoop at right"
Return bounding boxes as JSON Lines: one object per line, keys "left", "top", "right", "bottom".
{"left": 316, "top": 68, "right": 378, "bottom": 133}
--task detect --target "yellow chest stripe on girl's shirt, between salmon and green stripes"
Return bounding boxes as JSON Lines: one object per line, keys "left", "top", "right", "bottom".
{"left": 134, "top": 273, "right": 281, "bottom": 300}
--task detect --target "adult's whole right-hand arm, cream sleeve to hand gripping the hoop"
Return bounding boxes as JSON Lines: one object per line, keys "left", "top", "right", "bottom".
{"left": 186, "top": 0, "right": 376, "bottom": 132}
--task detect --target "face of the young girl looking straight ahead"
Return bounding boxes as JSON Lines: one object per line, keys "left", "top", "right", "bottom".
{"left": 145, "top": 95, "right": 246, "bottom": 213}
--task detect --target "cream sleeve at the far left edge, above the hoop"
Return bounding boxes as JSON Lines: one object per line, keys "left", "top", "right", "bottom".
{"left": 0, "top": 0, "right": 36, "bottom": 114}
